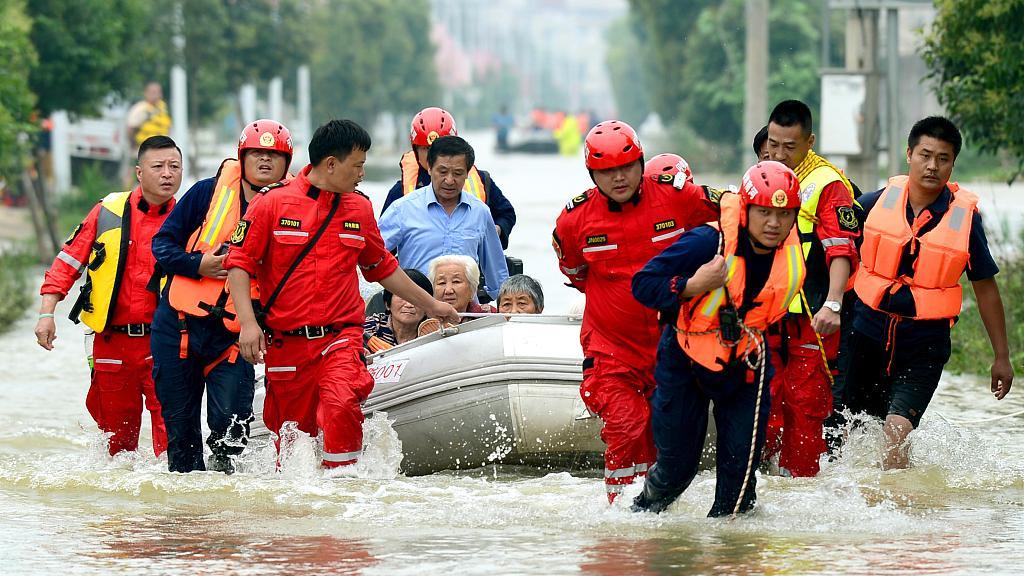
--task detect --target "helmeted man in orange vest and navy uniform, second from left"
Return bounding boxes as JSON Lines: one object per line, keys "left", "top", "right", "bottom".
{"left": 153, "top": 120, "right": 292, "bottom": 474}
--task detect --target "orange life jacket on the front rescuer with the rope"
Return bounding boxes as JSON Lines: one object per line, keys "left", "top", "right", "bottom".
{"left": 676, "top": 193, "right": 807, "bottom": 372}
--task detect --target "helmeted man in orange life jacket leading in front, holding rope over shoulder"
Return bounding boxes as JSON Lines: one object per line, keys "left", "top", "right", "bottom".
{"left": 632, "top": 161, "right": 805, "bottom": 517}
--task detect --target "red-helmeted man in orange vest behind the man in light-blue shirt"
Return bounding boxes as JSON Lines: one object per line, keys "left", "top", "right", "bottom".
{"left": 381, "top": 107, "right": 515, "bottom": 248}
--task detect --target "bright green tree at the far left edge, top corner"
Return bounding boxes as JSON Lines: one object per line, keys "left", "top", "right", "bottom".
{"left": 0, "top": 0, "right": 36, "bottom": 172}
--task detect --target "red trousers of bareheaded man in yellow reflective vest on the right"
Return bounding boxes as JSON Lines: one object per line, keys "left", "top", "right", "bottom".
{"left": 763, "top": 316, "right": 840, "bottom": 477}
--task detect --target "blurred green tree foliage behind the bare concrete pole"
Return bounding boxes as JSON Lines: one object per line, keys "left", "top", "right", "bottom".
{"left": 616, "top": 0, "right": 821, "bottom": 165}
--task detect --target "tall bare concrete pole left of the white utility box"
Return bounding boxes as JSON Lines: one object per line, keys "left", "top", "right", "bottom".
{"left": 739, "top": 0, "right": 768, "bottom": 150}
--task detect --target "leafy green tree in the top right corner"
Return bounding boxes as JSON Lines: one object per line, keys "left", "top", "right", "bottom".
{"left": 923, "top": 0, "right": 1024, "bottom": 181}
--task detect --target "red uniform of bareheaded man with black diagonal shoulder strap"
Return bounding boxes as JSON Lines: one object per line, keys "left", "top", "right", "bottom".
{"left": 224, "top": 166, "right": 398, "bottom": 467}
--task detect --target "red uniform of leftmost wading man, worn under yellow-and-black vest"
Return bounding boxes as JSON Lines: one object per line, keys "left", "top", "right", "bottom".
{"left": 39, "top": 188, "right": 174, "bottom": 455}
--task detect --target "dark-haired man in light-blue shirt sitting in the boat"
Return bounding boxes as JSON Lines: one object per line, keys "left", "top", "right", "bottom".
{"left": 379, "top": 136, "right": 509, "bottom": 298}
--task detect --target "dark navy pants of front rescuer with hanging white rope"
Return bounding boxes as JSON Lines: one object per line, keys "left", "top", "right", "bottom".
{"left": 638, "top": 334, "right": 771, "bottom": 517}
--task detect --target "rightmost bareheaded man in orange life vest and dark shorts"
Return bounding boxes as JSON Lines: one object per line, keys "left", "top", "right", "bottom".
{"left": 845, "top": 116, "right": 1014, "bottom": 468}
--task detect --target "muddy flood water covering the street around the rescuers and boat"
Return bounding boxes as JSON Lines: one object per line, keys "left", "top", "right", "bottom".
{"left": 0, "top": 133, "right": 1024, "bottom": 575}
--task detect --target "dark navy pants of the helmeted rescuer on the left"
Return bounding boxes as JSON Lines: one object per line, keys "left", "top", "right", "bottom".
{"left": 151, "top": 298, "right": 255, "bottom": 472}
